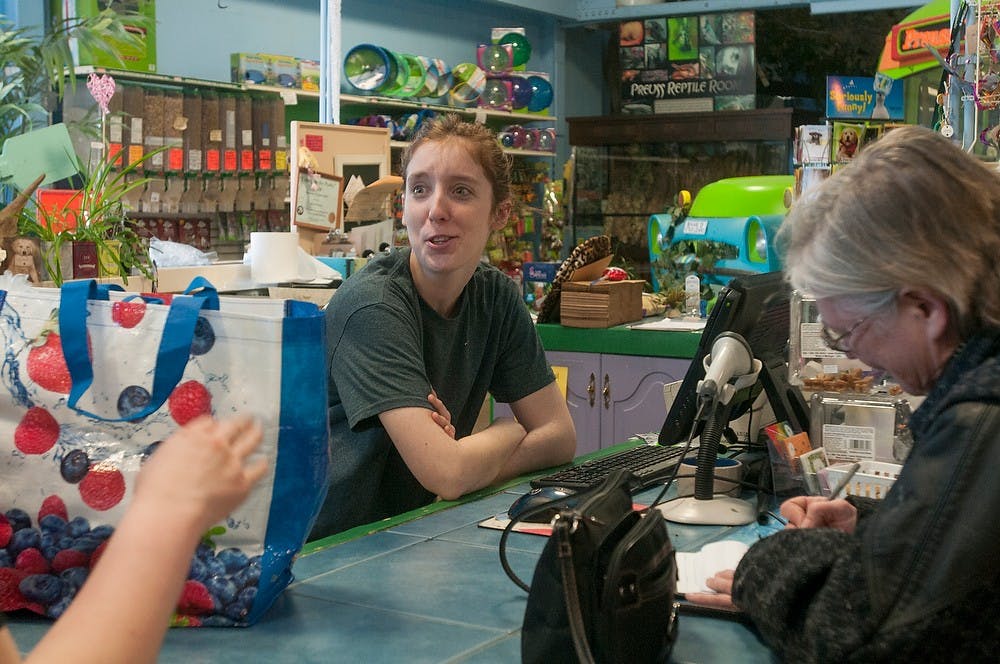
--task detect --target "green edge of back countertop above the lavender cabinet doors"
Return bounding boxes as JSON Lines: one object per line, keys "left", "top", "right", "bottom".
{"left": 535, "top": 323, "right": 701, "bottom": 360}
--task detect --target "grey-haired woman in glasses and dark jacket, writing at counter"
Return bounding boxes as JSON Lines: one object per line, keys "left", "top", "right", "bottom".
{"left": 693, "top": 127, "right": 1000, "bottom": 662}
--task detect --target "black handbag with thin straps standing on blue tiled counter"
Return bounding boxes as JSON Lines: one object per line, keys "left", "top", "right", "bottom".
{"left": 500, "top": 471, "right": 677, "bottom": 664}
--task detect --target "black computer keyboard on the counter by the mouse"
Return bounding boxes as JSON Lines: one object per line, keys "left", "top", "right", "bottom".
{"left": 531, "top": 445, "right": 684, "bottom": 491}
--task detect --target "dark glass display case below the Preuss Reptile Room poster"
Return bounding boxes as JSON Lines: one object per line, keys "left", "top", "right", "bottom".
{"left": 567, "top": 108, "right": 803, "bottom": 280}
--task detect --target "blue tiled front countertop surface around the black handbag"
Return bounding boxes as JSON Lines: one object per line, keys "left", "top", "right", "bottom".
{"left": 5, "top": 486, "right": 775, "bottom": 664}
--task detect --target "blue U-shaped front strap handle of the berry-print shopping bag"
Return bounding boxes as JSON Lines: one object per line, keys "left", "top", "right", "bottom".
{"left": 59, "top": 281, "right": 219, "bottom": 422}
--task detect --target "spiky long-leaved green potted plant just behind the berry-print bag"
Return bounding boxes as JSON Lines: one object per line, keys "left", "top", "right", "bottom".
{"left": 18, "top": 146, "right": 167, "bottom": 286}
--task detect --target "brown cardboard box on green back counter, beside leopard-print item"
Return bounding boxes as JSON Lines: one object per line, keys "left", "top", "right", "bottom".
{"left": 559, "top": 279, "right": 644, "bottom": 327}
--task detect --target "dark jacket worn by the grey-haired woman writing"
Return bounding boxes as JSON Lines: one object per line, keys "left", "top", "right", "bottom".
{"left": 733, "top": 330, "right": 1000, "bottom": 662}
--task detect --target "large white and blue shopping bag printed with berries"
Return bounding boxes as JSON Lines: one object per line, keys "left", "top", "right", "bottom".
{"left": 0, "top": 279, "right": 329, "bottom": 627}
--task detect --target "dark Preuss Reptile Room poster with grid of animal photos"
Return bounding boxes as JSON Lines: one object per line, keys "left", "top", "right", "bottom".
{"left": 618, "top": 12, "right": 757, "bottom": 114}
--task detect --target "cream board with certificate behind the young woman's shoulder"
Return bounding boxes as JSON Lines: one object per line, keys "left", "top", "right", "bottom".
{"left": 290, "top": 121, "right": 391, "bottom": 246}
